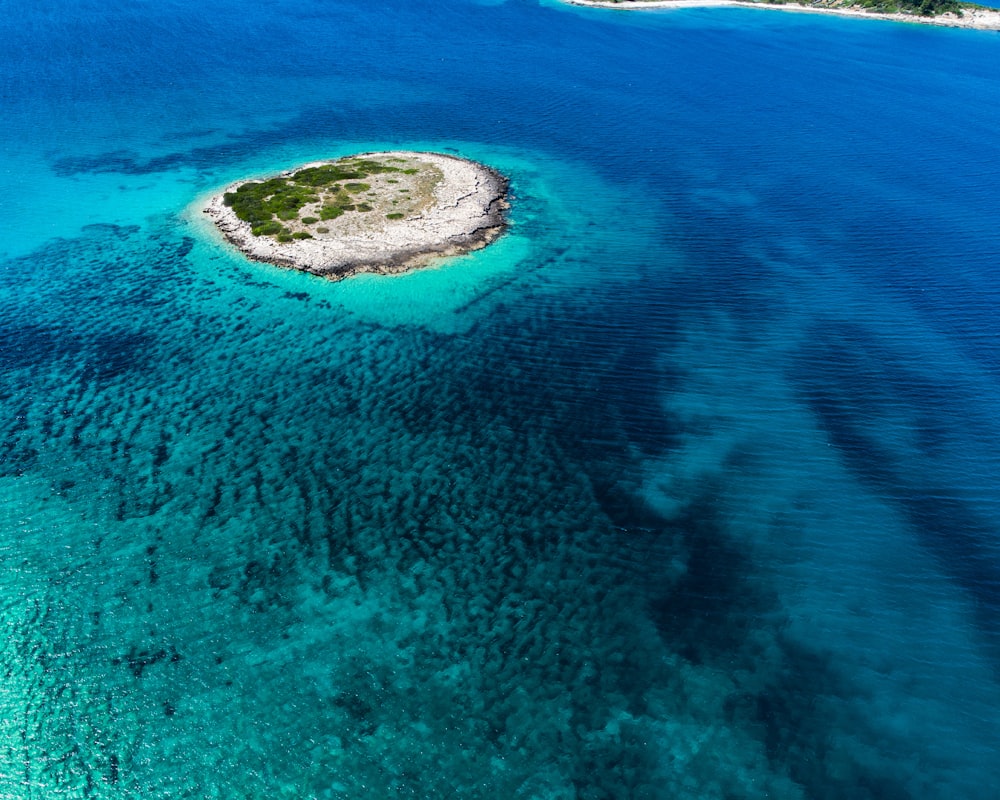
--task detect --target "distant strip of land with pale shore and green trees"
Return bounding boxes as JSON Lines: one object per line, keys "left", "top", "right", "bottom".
{"left": 562, "top": 0, "right": 1000, "bottom": 31}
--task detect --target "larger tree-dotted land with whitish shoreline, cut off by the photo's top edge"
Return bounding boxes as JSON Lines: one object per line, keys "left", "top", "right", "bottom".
{"left": 563, "top": 0, "right": 1000, "bottom": 31}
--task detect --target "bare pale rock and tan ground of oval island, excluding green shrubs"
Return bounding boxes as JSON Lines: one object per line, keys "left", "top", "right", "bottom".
{"left": 204, "top": 150, "right": 509, "bottom": 280}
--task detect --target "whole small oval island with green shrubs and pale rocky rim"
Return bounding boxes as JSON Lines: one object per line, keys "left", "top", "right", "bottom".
{"left": 204, "top": 151, "right": 509, "bottom": 280}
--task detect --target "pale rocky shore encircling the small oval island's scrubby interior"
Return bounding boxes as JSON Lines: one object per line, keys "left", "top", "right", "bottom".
{"left": 204, "top": 151, "right": 508, "bottom": 279}
